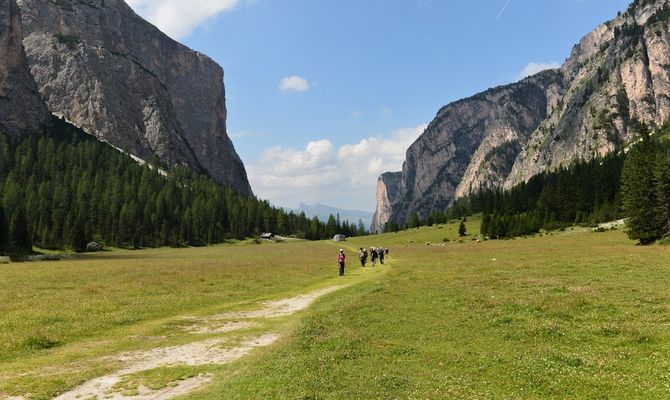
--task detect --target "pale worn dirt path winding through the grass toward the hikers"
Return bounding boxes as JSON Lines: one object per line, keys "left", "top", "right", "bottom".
{"left": 55, "top": 286, "right": 343, "bottom": 400}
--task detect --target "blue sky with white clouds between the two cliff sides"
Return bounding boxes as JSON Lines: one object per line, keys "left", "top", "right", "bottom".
{"left": 127, "top": 0, "right": 629, "bottom": 211}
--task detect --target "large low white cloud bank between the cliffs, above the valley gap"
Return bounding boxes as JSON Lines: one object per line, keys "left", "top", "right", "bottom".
{"left": 247, "top": 124, "right": 427, "bottom": 210}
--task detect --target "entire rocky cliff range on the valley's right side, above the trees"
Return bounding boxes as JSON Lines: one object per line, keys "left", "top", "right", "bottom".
{"left": 378, "top": 0, "right": 670, "bottom": 228}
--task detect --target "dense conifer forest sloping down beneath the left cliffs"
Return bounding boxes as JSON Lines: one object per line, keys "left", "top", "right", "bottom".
{"left": 0, "top": 120, "right": 365, "bottom": 254}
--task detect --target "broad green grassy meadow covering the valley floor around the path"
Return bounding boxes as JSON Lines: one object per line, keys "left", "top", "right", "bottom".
{"left": 0, "top": 218, "right": 670, "bottom": 399}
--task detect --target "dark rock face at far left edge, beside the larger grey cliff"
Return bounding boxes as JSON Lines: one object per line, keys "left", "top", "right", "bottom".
{"left": 0, "top": 0, "right": 51, "bottom": 136}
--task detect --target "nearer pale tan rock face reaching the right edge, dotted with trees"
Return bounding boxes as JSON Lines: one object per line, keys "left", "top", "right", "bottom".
{"left": 505, "top": 0, "right": 670, "bottom": 187}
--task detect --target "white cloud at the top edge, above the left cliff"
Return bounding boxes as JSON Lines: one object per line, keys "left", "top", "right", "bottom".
{"left": 127, "top": 0, "right": 241, "bottom": 39}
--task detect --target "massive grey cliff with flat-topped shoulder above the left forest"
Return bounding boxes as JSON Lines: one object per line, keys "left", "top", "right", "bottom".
{"left": 18, "top": 0, "right": 251, "bottom": 194}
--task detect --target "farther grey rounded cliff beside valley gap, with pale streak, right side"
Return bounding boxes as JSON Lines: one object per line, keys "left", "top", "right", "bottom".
{"left": 379, "top": 71, "right": 564, "bottom": 226}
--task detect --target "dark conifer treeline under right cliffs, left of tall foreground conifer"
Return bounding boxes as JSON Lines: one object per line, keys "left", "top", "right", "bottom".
{"left": 387, "top": 147, "right": 624, "bottom": 239}
